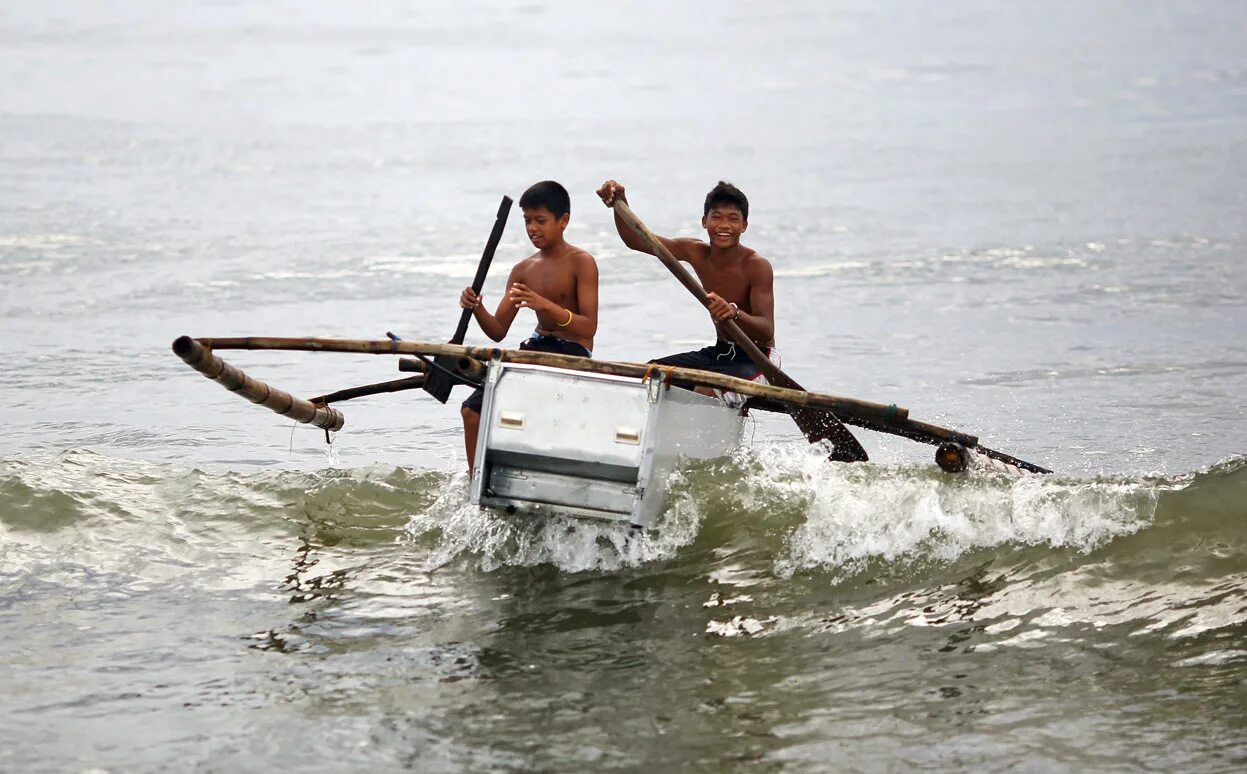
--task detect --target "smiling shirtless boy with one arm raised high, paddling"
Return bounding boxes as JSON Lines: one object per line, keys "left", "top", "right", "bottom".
{"left": 597, "top": 179, "right": 779, "bottom": 391}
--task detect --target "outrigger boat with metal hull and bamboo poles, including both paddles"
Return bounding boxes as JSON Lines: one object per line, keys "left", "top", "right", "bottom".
{"left": 173, "top": 197, "right": 1051, "bottom": 527}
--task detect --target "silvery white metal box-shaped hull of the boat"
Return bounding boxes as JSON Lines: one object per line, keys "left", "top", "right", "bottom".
{"left": 471, "top": 361, "right": 744, "bottom": 527}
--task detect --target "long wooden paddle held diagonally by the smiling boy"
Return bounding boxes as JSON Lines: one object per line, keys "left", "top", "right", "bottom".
{"left": 607, "top": 199, "right": 868, "bottom": 462}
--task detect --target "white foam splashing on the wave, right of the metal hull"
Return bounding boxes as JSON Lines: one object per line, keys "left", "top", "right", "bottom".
{"left": 728, "top": 446, "right": 1158, "bottom": 576}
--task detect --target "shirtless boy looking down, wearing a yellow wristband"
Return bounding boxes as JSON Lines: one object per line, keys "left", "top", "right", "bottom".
{"left": 459, "top": 179, "right": 597, "bottom": 471}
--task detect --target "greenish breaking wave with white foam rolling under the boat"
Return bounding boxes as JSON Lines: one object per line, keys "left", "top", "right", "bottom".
{"left": 0, "top": 446, "right": 1247, "bottom": 583}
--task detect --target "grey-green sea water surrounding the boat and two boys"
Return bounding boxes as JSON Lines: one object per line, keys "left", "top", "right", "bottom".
{"left": 0, "top": 0, "right": 1247, "bottom": 772}
